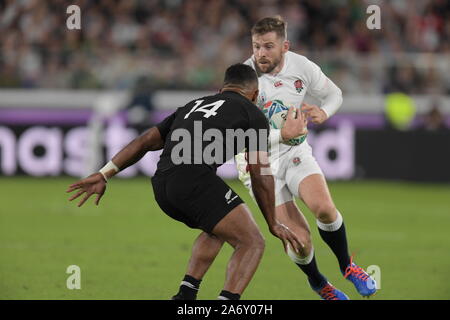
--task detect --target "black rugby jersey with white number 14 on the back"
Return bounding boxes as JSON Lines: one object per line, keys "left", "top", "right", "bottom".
{"left": 156, "top": 91, "right": 269, "bottom": 171}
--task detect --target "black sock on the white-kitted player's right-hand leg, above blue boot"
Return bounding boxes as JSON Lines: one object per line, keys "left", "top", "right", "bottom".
{"left": 319, "top": 222, "right": 350, "bottom": 273}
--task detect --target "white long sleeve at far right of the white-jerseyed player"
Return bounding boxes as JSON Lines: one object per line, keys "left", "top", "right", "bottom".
{"left": 305, "top": 60, "right": 343, "bottom": 118}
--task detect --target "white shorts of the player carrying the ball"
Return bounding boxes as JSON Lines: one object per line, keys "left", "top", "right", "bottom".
{"left": 236, "top": 141, "right": 323, "bottom": 206}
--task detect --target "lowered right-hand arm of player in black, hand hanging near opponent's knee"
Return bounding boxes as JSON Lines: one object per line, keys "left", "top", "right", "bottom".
{"left": 249, "top": 151, "right": 303, "bottom": 252}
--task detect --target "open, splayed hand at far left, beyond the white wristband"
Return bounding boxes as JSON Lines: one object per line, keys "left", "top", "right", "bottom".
{"left": 66, "top": 172, "right": 106, "bottom": 207}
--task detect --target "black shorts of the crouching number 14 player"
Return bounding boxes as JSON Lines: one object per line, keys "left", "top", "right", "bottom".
{"left": 152, "top": 165, "right": 243, "bottom": 233}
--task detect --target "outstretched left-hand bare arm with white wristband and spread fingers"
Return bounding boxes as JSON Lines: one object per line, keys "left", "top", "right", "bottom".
{"left": 67, "top": 127, "right": 164, "bottom": 207}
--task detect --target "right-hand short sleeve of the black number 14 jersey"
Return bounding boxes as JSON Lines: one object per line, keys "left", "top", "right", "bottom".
{"left": 246, "top": 105, "right": 270, "bottom": 152}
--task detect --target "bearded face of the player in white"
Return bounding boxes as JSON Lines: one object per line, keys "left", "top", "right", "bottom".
{"left": 252, "top": 32, "right": 284, "bottom": 73}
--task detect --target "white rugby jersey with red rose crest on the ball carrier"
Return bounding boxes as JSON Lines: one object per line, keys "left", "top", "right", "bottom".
{"left": 244, "top": 51, "right": 342, "bottom": 158}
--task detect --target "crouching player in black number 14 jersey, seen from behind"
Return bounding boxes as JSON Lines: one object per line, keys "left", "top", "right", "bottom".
{"left": 67, "top": 64, "right": 306, "bottom": 300}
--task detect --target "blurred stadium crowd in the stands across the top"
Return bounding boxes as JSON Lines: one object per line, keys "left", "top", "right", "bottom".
{"left": 0, "top": 0, "right": 450, "bottom": 94}
